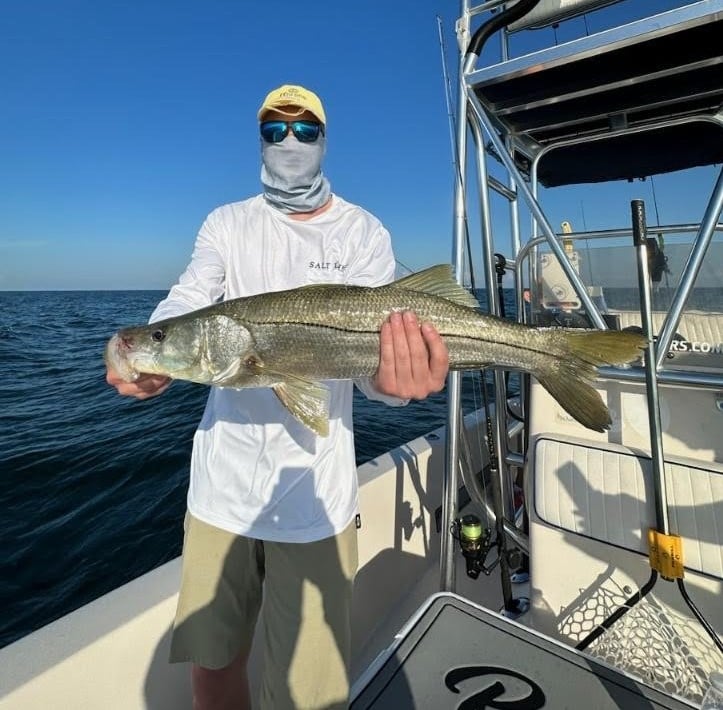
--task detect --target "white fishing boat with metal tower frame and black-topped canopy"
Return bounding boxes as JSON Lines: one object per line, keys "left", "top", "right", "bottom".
{"left": 0, "top": 0, "right": 723, "bottom": 710}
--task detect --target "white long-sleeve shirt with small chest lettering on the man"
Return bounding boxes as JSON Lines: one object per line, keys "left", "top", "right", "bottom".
{"left": 150, "top": 195, "right": 404, "bottom": 542}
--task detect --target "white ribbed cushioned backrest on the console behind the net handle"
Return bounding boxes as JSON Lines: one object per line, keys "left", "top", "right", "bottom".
{"left": 533, "top": 437, "right": 723, "bottom": 579}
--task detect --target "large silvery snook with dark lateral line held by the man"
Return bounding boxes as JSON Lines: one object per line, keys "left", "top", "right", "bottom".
{"left": 105, "top": 265, "right": 646, "bottom": 436}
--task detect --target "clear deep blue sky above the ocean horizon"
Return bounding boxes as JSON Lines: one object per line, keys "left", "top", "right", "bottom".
{"left": 0, "top": 0, "right": 715, "bottom": 290}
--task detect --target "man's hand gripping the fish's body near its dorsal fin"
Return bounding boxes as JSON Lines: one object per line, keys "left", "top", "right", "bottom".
{"left": 372, "top": 311, "right": 449, "bottom": 399}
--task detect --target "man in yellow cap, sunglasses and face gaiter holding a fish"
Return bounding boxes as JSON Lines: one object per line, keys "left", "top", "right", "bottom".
{"left": 107, "top": 85, "right": 448, "bottom": 710}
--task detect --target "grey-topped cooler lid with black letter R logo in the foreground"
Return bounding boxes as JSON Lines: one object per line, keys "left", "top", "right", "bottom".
{"left": 351, "top": 594, "right": 689, "bottom": 710}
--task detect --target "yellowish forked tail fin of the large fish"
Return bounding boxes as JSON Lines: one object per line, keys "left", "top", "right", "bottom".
{"left": 533, "top": 330, "right": 647, "bottom": 432}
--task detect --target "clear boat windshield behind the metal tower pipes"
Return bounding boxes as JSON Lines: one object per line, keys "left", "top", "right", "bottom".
{"left": 525, "top": 226, "right": 723, "bottom": 371}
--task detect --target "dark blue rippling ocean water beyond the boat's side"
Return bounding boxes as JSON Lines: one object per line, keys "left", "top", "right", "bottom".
{"left": 0, "top": 291, "right": 511, "bottom": 647}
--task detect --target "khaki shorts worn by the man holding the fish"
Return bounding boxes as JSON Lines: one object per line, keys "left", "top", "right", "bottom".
{"left": 170, "top": 514, "right": 357, "bottom": 710}
